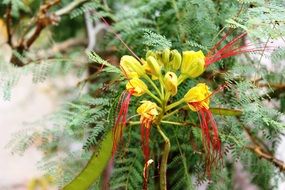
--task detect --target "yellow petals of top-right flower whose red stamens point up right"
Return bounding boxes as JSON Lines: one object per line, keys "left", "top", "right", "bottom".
{"left": 181, "top": 51, "right": 205, "bottom": 78}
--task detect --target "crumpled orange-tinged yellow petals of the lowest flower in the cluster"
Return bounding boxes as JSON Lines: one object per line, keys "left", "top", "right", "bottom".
{"left": 137, "top": 101, "right": 158, "bottom": 127}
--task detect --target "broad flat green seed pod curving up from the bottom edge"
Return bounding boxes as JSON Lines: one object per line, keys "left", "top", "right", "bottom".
{"left": 63, "top": 130, "right": 113, "bottom": 190}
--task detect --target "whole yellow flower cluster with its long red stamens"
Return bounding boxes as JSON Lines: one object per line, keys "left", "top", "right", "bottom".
{"left": 113, "top": 33, "right": 266, "bottom": 179}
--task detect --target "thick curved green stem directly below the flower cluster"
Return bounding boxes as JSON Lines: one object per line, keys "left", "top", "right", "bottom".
{"left": 156, "top": 125, "right": 170, "bottom": 190}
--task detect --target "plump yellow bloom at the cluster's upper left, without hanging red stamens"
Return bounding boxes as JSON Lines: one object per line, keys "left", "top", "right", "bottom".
{"left": 120, "top": 55, "right": 145, "bottom": 79}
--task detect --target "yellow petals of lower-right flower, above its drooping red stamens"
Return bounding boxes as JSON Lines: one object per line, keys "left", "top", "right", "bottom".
{"left": 184, "top": 83, "right": 211, "bottom": 111}
